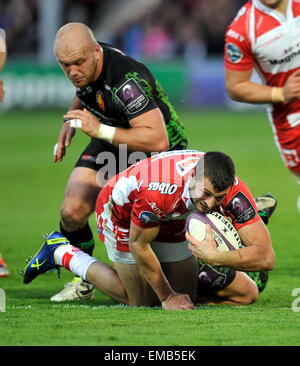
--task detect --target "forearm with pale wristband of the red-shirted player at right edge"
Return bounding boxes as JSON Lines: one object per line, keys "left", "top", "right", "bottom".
{"left": 226, "top": 81, "right": 283, "bottom": 104}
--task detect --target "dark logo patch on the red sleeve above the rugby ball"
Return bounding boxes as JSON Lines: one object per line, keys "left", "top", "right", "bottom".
{"left": 226, "top": 192, "right": 255, "bottom": 224}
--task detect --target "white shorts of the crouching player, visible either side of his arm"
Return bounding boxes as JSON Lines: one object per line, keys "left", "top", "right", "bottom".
{"left": 105, "top": 236, "right": 192, "bottom": 264}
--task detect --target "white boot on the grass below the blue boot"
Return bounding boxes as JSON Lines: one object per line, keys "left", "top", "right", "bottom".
{"left": 50, "top": 277, "right": 95, "bottom": 302}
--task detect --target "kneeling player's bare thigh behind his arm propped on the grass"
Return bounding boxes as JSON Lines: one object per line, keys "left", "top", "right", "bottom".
{"left": 113, "top": 262, "right": 160, "bottom": 306}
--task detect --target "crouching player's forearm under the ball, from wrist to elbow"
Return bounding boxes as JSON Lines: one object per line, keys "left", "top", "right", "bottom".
{"left": 210, "top": 245, "right": 274, "bottom": 271}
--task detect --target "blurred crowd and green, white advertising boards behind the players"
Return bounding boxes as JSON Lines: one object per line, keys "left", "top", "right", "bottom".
{"left": 0, "top": 0, "right": 247, "bottom": 110}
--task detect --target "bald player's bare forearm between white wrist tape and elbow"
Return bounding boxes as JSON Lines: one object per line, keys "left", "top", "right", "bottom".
{"left": 113, "top": 127, "right": 169, "bottom": 152}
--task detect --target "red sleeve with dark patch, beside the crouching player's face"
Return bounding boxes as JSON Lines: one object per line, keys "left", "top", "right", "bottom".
{"left": 222, "top": 177, "right": 261, "bottom": 230}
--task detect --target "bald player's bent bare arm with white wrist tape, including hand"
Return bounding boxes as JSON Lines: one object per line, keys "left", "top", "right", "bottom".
{"left": 64, "top": 108, "right": 169, "bottom": 152}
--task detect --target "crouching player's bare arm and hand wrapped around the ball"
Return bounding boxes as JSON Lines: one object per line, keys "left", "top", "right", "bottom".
{"left": 186, "top": 221, "right": 275, "bottom": 271}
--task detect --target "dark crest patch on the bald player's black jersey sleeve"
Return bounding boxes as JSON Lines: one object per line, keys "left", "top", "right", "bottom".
{"left": 116, "top": 79, "right": 149, "bottom": 114}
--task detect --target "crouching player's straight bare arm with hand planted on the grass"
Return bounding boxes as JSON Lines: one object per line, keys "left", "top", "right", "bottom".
{"left": 129, "top": 222, "right": 194, "bottom": 310}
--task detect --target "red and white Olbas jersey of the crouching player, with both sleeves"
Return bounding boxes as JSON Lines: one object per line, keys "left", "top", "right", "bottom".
{"left": 96, "top": 150, "right": 260, "bottom": 251}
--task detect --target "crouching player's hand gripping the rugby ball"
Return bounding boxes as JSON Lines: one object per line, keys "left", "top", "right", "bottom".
{"left": 185, "top": 224, "right": 218, "bottom": 264}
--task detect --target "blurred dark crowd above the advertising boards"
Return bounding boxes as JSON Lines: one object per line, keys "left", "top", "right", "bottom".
{"left": 0, "top": 0, "right": 245, "bottom": 60}
